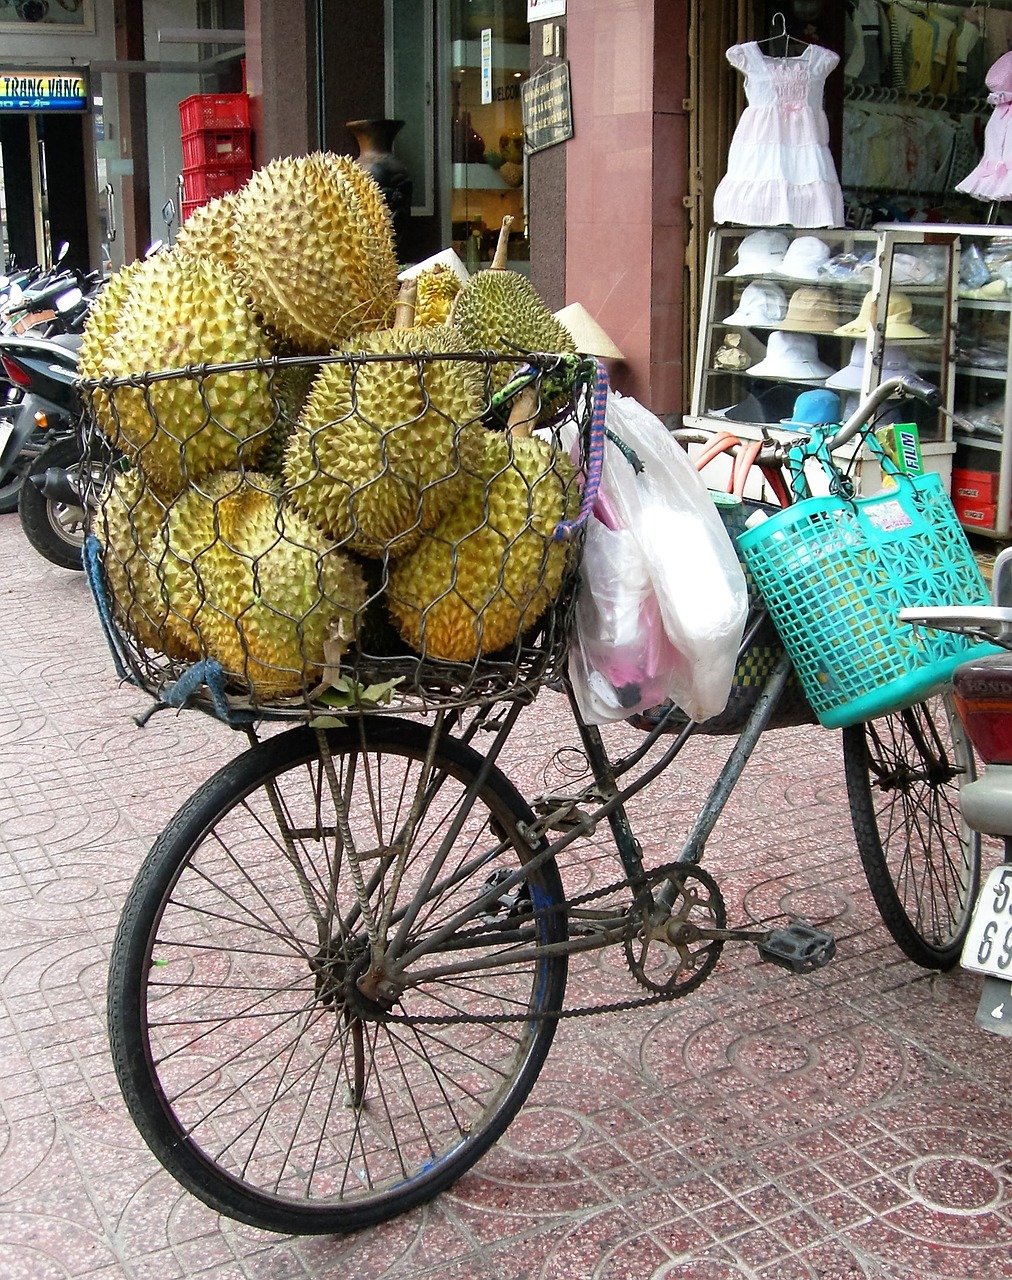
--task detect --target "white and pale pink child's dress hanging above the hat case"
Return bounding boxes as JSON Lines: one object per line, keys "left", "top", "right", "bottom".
{"left": 714, "top": 41, "right": 843, "bottom": 227}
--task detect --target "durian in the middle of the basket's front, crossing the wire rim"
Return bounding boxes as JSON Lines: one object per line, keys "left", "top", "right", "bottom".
{"left": 284, "top": 326, "right": 485, "bottom": 557}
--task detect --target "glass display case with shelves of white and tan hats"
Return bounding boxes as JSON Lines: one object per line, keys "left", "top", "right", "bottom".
{"left": 686, "top": 225, "right": 958, "bottom": 494}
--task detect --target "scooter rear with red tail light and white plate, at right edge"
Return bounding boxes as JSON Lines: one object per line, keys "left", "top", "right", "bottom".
{"left": 899, "top": 547, "right": 1012, "bottom": 1038}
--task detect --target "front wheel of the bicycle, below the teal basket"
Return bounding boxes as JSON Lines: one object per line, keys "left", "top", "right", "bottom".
{"left": 843, "top": 694, "right": 980, "bottom": 969}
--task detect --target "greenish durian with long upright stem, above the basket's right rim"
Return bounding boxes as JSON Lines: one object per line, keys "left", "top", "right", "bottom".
{"left": 450, "top": 216, "right": 576, "bottom": 390}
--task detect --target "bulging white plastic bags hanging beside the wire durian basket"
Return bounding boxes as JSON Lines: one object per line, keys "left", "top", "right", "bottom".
{"left": 571, "top": 392, "right": 748, "bottom": 723}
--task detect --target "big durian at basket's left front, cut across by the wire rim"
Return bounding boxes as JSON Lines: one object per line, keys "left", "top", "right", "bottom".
{"left": 82, "top": 250, "right": 274, "bottom": 497}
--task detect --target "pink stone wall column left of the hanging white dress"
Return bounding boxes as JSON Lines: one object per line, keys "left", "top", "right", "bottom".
{"left": 565, "top": 0, "right": 688, "bottom": 413}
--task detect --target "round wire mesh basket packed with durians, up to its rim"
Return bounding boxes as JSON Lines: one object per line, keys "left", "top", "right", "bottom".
{"left": 81, "top": 352, "right": 596, "bottom": 722}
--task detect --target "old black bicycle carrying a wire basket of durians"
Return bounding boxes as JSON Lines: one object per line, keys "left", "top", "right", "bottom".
{"left": 86, "top": 356, "right": 980, "bottom": 1234}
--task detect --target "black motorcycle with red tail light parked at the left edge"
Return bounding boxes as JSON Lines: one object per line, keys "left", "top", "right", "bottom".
{"left": 0, "top": 334, "right": 107, "bottom": 568}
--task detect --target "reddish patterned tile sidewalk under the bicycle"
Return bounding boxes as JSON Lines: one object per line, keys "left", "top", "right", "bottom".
{"left": 0, "top": 516, "right": 1012, "bottom": 1280}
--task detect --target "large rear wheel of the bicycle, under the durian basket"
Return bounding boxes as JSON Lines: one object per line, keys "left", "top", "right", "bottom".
{"left": 107, "top": 717, "right": 567, "bottom": 1234}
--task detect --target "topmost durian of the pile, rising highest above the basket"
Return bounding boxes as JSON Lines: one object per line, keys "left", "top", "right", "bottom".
{"left": 234, "top": 151, "right": 397, "bottom": 355}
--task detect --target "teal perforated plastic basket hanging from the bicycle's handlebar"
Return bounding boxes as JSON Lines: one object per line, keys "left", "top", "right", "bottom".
{"left": 738, "top": 431, "right": 999, "bottom": 728}
